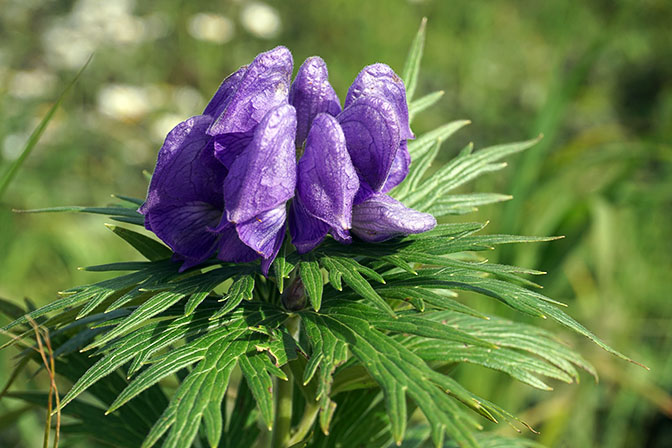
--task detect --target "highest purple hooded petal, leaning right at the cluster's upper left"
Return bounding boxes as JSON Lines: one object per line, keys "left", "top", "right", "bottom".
{"left": 208, "top": 47, "right": 293, "bottom": 135}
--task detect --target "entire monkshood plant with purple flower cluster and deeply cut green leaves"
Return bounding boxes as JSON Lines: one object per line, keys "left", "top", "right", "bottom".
{"left": 5, "top": 19, "right": 627, "bottom": 448}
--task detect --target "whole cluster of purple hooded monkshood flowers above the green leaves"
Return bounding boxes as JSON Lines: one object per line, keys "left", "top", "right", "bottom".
{"left": 140, "top": 47, "right": 436, "bottom": 274}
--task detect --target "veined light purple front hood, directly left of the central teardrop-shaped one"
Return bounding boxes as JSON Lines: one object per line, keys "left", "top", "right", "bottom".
{"left": 224, "top": 104, "right": 296, "bottom": 223}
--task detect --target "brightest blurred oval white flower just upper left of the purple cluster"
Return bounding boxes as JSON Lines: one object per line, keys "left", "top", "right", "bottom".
{"left": 98, "top": 84, "right": 151, "bottom": 121}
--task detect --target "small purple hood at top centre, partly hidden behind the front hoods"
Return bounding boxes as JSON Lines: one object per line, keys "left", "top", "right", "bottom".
{"left": 289, "top": 56, "right": 341, "bottom": 146}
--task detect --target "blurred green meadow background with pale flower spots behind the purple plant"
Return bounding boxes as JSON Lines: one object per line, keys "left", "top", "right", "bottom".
{"left": 0, "top": 0, "right": 672, "bottom": 448}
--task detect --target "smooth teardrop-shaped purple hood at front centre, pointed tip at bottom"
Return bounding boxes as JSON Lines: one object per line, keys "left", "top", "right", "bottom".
{"left": 296, "top": 113, "right": 359, "bottom": 238}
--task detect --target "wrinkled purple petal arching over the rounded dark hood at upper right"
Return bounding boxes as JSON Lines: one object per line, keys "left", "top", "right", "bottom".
{"left": 345, "top": 64, "right": 415, "bottom": 140}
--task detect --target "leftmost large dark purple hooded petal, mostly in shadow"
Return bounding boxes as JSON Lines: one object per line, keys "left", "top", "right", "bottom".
{"left": 139, "top": 115, "right": 226, "bottom": 261}
